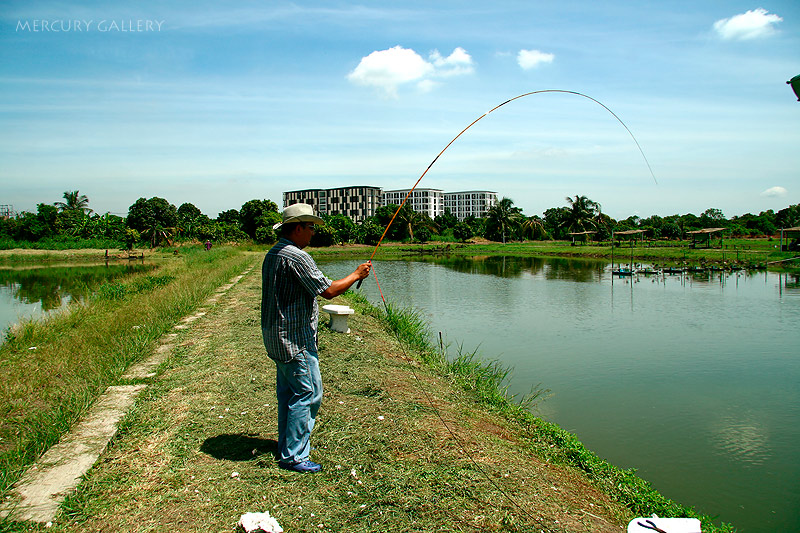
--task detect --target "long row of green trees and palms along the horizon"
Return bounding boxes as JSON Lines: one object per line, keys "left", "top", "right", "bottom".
{"left": 0, "top": 191, "right": 800, "bottom": 249}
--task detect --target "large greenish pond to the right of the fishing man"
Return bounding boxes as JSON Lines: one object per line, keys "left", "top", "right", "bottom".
{"left": 319, "top": 257, "right": 800, "bottom": 532}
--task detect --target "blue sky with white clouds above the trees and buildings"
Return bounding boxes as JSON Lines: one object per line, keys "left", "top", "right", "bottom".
{"left": 0, "top": 0, "right": 800, "bottom": 218}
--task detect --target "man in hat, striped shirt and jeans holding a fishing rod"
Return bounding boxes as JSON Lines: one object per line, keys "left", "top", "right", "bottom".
{"left": 261, "top": 204, "right": 370, "bottom": 473}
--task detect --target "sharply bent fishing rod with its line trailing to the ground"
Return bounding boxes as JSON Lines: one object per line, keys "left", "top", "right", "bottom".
{"left": 356, "top": 89, "right": 658, "bottom": 527}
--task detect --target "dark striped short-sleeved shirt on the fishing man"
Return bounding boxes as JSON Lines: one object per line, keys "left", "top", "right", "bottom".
{"left": 261, "top": 239, "right": 332, "bottom": 363}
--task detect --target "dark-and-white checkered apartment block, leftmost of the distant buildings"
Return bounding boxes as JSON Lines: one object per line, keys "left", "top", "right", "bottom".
{"left": 283, "top": 185, "right": 381, "bottom": 222}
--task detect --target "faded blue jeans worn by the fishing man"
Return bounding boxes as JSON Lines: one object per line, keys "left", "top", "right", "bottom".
{"left": 275, "top": 350, "right": 322, "bottom": 464}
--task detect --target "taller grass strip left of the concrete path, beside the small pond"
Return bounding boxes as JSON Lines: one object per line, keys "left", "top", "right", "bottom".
{"left": 0, "top": 247, "right": 251, "bottom": 492}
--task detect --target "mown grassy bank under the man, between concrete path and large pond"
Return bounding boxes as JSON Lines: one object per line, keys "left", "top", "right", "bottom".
{"left": 0, "top": 264, "right": 728, "bottom": 533}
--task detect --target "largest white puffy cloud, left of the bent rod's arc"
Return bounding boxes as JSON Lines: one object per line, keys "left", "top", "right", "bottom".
{"left": 347, "top": 46, "right": 475, "bottom": 97}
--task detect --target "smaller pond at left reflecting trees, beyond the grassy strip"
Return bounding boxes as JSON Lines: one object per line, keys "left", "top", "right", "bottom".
{"left": 0, "top": 263, "right": 153, "bottom": 336}
